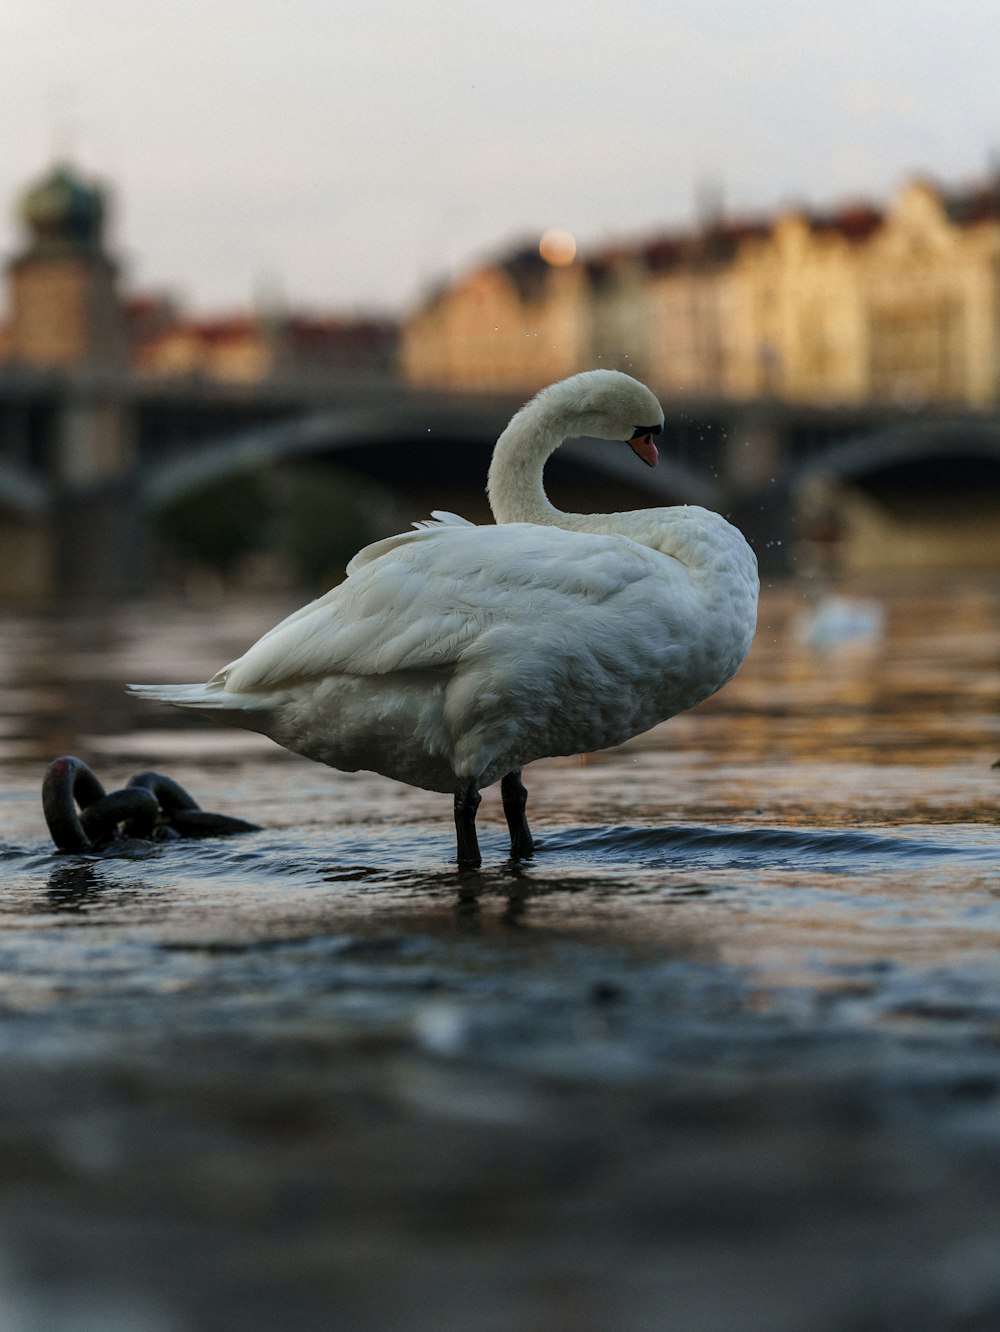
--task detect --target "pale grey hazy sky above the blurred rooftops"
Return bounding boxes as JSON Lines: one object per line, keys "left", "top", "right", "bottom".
{"left": 0, "top": 0, "right": 1000, "bottom": 313}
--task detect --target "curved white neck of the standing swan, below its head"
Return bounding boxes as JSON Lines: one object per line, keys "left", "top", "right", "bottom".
{"left": 486, "top": 401, "right": 570, "bottom": 526}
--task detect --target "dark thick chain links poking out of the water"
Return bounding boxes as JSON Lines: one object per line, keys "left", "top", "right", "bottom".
{"left": 41, "top": 754, "right": 260, "bottom": 854}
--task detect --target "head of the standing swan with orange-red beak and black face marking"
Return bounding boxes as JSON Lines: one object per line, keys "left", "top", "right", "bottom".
{"left": 539, "top": 370, "right": 663, "bottom": 468}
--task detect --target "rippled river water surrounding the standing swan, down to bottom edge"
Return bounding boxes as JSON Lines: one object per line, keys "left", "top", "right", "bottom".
{"left": 0, "top": 581, "right": 1000, "bottom": 1332}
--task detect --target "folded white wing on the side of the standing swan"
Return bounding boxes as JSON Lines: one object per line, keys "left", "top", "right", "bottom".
{"left": 214, "top": 523, "right": 672, "bottom": 691}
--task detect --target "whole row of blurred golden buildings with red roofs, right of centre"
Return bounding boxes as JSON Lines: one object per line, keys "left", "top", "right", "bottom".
{"left": 401, "top": 181, "right": 1000, "bottom": 406}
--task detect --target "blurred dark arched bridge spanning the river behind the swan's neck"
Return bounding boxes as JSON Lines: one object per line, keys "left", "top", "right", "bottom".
{"left": 0, "top": 370, "right": 1000, "bottom": 595}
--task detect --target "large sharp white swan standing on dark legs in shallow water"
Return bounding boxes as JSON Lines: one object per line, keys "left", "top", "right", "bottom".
{"left": 130, "top": 370, "right": 758, "bottom": 864}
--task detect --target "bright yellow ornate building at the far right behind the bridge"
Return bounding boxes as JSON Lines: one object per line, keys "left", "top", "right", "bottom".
{"left": 734, "top": 181, "right": 1000, "bottom": 406}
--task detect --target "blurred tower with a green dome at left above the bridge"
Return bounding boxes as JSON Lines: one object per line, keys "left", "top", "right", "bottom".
{"left": 8, "top": 165, "right": 126, "bottom": 369}
